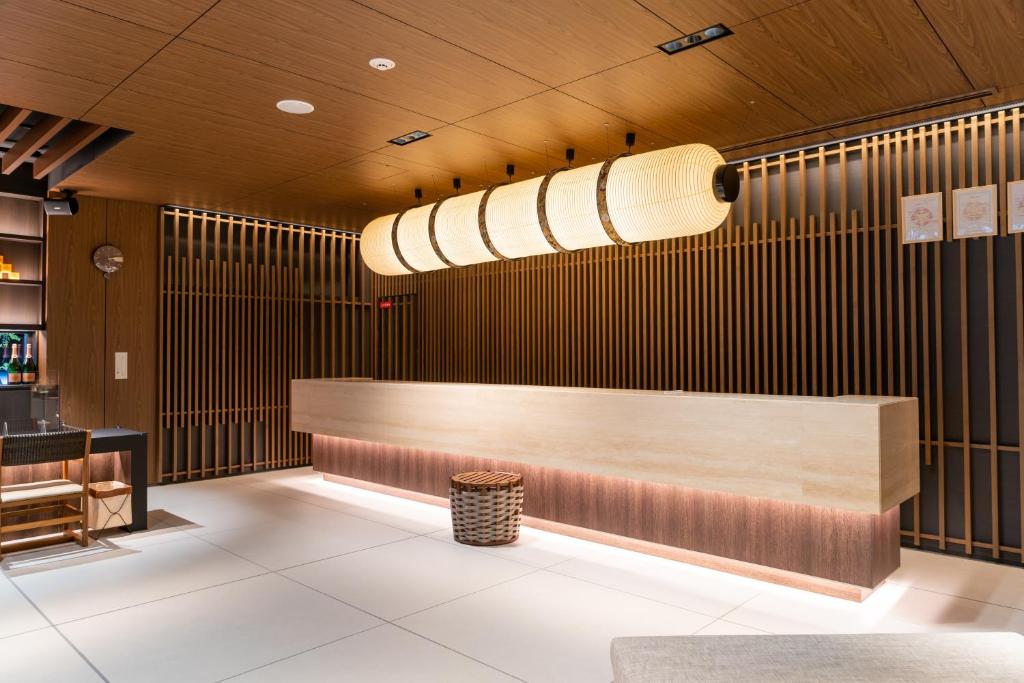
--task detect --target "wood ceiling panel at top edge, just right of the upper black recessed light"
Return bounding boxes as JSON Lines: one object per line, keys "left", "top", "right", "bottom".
{"left": 708, "top": 0, "right": 971, "bottom": 123}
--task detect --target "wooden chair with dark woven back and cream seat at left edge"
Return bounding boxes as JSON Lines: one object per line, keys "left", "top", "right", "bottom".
{"left": 0, "top": 429, "right": 92, "bottom": 557}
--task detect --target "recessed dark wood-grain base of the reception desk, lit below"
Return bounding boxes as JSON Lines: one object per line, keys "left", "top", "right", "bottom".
{"left": 312, "top": 434, "right": 899, "bottom": 600}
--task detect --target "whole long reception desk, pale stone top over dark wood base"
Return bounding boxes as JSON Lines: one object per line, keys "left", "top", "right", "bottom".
{"left": 292, "top": 380, "right": 919, "bottom": 599}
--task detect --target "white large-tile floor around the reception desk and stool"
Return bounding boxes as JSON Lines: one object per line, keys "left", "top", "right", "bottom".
{"left": 0, "top": 469, "right": 1024, "bottom": 683}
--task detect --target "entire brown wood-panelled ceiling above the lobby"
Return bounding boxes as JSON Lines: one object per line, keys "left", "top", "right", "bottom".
{"left": 0, "top": 0, "right": 1024, "bottom": 228}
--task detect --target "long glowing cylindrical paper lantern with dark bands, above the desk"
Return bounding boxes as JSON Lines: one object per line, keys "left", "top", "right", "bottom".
{"left": 360, "top": 144, "right": 739, "bottom": 275}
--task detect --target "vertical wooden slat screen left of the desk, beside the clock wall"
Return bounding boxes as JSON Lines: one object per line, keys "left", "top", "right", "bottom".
{"left": 160, "top": 208, "right": 373, "bottom": 481}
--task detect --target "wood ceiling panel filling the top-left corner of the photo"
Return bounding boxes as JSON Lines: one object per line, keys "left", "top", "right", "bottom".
{"left": 0, "top": 0, "right": 169, "bottom": 90}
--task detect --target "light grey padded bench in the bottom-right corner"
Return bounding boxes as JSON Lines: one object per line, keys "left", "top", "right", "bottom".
{"left": 611, "top": 633, "right": 1024, "bottom": 683}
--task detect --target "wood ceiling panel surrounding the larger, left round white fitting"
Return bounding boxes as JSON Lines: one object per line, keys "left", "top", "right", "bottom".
{"left": 123, "top": 40, "right": 442, "bottom": 151}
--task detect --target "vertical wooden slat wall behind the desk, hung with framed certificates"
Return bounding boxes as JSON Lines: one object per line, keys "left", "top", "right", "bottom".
{"left": 373, "top": 109, "right": 1024, "bottom": 562}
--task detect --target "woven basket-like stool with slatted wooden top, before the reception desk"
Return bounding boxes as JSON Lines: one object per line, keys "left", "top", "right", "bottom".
{"left": 449, "top": 472, "right": 522, "bottom": 546}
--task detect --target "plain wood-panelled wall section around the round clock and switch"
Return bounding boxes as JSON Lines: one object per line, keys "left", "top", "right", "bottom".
{"left": 45, "top": 197, "right": 160, "bottom": 481}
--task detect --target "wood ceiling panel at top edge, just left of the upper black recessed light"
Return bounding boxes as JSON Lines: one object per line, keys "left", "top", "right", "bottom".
{"left": 362, "top": 0, "right": 676, "bottom": 86}
